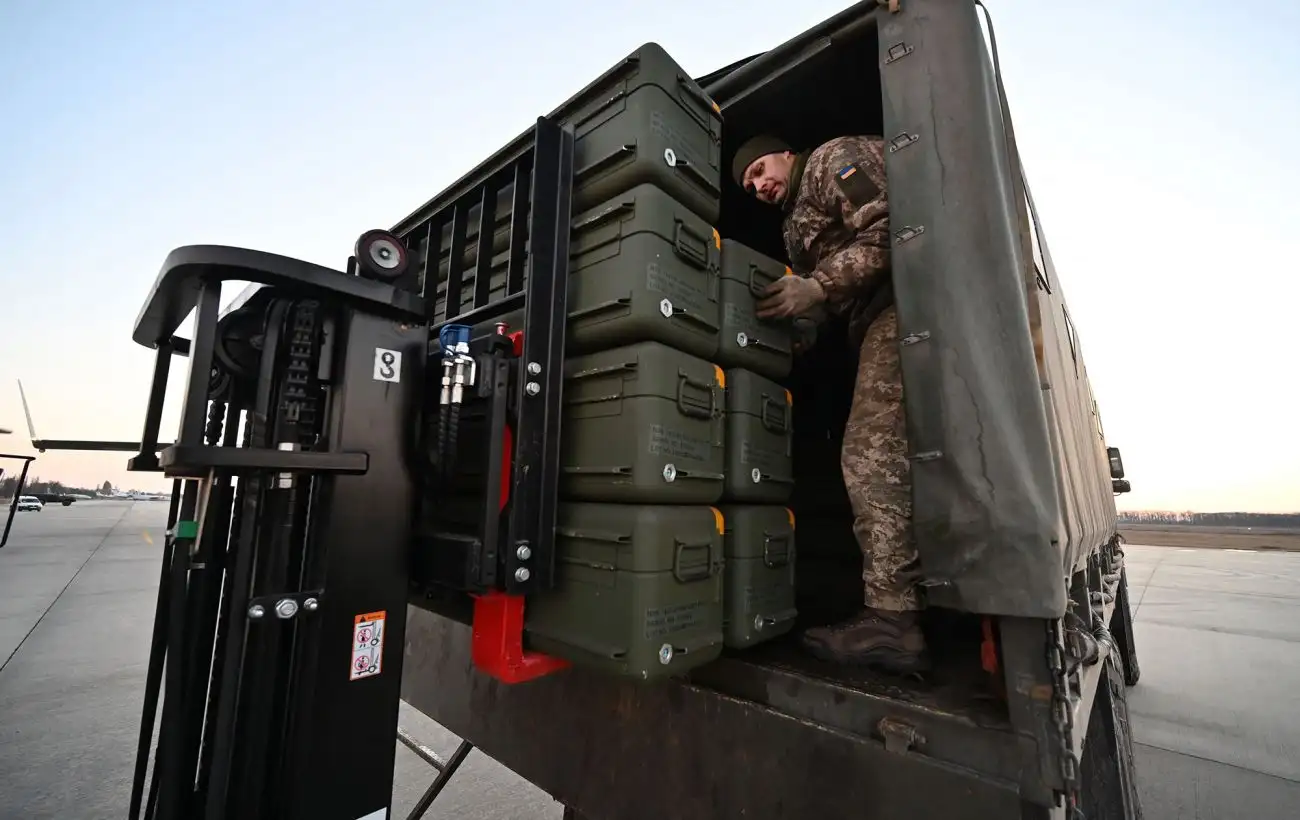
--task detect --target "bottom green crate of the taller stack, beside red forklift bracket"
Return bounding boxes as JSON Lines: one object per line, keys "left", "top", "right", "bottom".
{"left": 524, "top": 503, "right": 725, "bottom": 680}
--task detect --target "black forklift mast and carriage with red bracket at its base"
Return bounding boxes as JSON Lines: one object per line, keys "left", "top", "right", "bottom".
{"left": 111, "top": 118, "right": 573, "bottom": 820}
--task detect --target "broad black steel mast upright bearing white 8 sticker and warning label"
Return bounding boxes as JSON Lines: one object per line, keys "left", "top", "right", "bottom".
{"left": 280, "top": 311, "right": 429, "bottom": 820}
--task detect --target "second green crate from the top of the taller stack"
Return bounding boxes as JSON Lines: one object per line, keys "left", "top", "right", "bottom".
{"left": 434, "top": 185, "right": 719, "bottom": 357}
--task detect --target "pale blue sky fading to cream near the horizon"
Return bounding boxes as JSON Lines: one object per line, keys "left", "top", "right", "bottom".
{"left": 0, "top": 0, "right": 1300, "bottom": 512}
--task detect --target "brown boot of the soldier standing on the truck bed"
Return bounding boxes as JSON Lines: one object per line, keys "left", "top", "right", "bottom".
{"left": 802, "top": 607, "right": 930, "bottom": 674}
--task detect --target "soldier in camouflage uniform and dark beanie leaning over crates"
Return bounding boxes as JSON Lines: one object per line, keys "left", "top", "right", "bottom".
{"left": 732, "top": 135, "right": 928, "bottom": 673}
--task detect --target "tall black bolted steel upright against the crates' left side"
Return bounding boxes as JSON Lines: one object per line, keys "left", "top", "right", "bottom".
{"left": 506, "top": 118, "right": 573, "bottom": 593}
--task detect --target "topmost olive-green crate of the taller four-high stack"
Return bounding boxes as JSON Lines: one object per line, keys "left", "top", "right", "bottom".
{"left": 412, "top": 43, "right": 723, "bottom": 294}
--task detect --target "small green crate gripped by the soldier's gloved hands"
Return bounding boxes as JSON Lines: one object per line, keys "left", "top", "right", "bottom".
{"left": 714, "top": 239, "right": 794, "bottom": 378}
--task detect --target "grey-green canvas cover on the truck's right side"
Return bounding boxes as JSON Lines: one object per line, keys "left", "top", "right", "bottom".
{"left": 706, "top": 0, "right": 1114, "bottom": 617}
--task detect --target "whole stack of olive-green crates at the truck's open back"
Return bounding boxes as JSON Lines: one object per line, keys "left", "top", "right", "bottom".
{"left": 436, "top": 44, "right": 793, "bottom": 680}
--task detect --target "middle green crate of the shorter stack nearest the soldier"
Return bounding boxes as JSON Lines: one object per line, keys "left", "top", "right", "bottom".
{"left": 723, "top": 370, "right": 794, "bottom": 504}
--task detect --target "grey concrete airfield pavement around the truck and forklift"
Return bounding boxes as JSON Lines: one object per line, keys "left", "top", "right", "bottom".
{"left": 0, "top": 502, "right": 1300, "bottom": 820}
